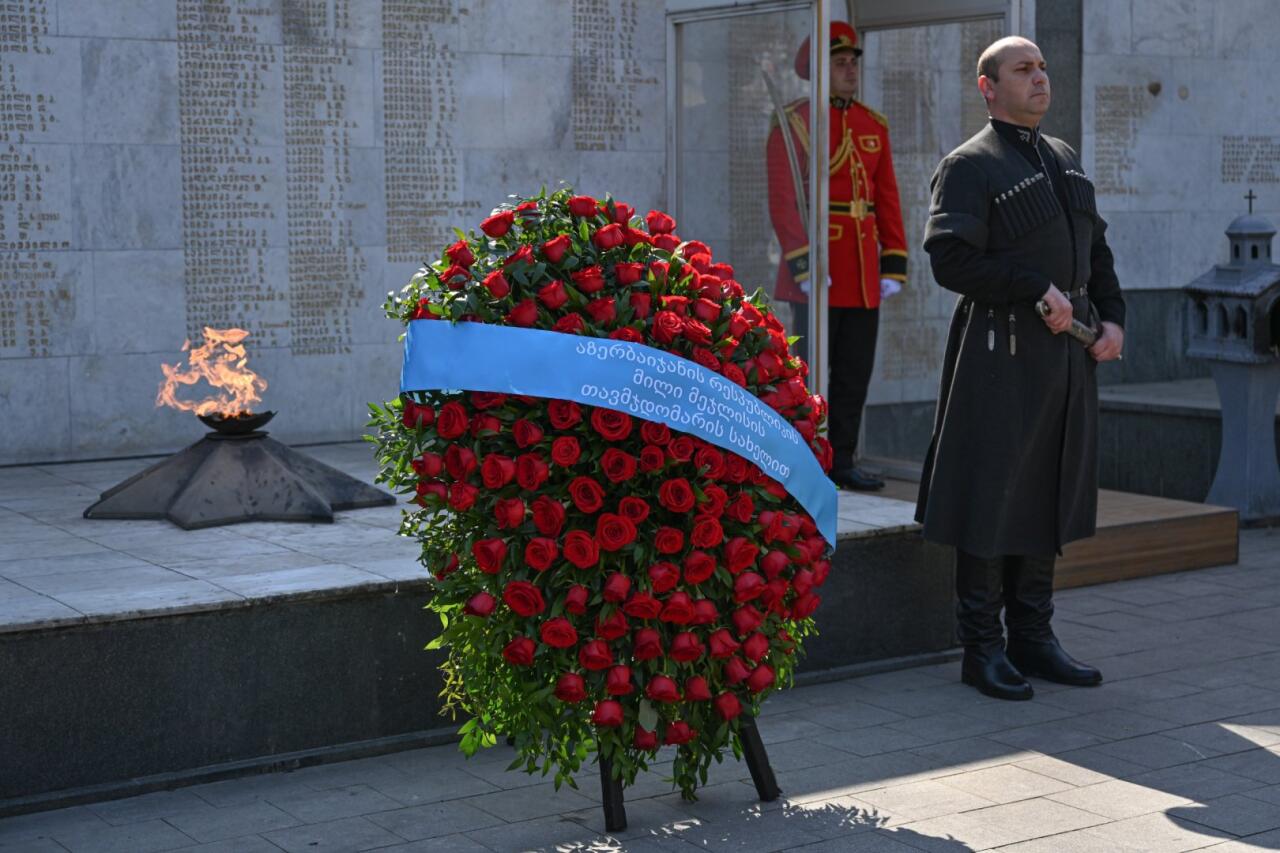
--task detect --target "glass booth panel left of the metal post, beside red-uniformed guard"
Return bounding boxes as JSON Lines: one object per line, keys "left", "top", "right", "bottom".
{"left": 675, "top": 9, "right": 812, "bottom": 348}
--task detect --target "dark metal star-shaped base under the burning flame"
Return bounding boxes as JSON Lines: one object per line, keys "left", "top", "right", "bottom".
{"left": 84, "top": 422, "right": 396, "bottom": 530}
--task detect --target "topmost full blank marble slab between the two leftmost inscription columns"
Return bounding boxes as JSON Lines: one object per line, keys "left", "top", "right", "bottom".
{"left": 81, "top": 38, "right": 180, "bottom": 145}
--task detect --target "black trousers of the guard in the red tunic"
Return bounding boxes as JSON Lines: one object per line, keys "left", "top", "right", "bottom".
{"left": 790, "top": 302, "right": 879, "bottom": 467}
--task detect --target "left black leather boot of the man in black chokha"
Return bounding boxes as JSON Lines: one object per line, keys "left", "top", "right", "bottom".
{"left": 956, "top": 549, "right": 1033, "bottom": 699}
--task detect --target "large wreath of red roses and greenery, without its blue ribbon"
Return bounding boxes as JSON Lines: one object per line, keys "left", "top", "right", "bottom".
{"left": 371, "top": 190, "right": 831, "bottom": 798}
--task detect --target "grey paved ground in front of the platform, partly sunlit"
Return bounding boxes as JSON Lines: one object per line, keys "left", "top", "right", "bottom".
{"left": 0, "top": 530, "right": 1280, "bottom": 853}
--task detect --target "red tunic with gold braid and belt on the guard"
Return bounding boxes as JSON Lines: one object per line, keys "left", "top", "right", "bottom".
{"left": 767, "top": 99, "right": 906, "bottom": 307}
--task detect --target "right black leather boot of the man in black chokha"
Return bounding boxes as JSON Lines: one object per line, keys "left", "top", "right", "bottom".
{"left": 1005, "top": 557, "right": 1102, "bottom": 686}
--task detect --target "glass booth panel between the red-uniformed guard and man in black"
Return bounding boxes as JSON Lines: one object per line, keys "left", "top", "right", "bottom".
{"left": 861, "top": 17, "right": 1005, "bottom": 409}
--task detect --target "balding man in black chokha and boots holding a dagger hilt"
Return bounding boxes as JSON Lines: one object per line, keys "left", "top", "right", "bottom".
{"left": 916, "top": 37, "right": 1125, "bottom": 699}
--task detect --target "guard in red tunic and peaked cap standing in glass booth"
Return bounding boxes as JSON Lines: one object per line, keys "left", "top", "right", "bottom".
{"left": 768, "top": 20, "right": 906, "bottom": 491}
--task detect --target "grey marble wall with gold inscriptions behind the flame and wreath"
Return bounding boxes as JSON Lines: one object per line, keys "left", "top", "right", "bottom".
{"left": 0, "top": 0, "right": 666, "bottom": 464}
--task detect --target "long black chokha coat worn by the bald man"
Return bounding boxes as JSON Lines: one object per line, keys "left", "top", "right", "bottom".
{"left": 916, "top": 122, "right": 1124, "bottom": 557}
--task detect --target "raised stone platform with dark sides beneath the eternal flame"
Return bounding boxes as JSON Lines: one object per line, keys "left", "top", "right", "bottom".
{"left": 0, "top": 443, "right": 952, "bottom": 813}
